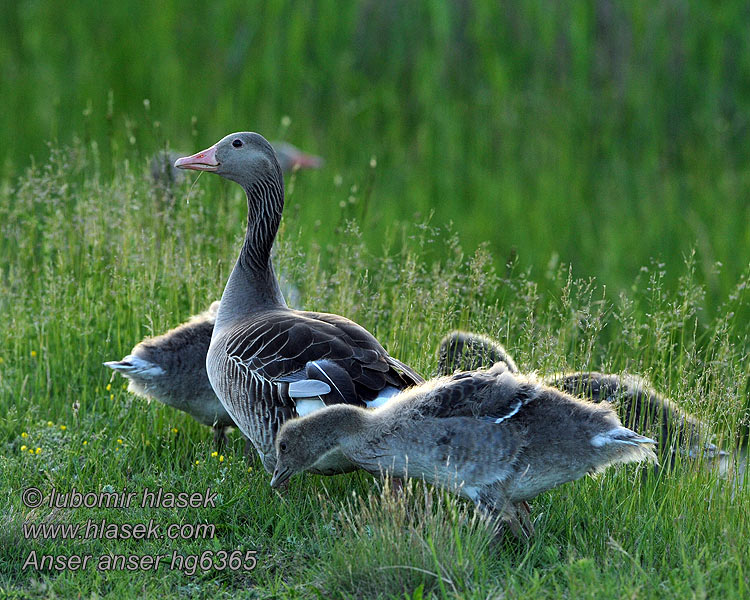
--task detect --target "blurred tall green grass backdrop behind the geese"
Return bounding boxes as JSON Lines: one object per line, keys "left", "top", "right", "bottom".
{"left": 0, "top": 0, "right": 750, "bottom": 324}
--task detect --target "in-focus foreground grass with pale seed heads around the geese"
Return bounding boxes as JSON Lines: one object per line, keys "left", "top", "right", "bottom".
{"left": 0, "top": 142, "right": 750, "bottom": 599}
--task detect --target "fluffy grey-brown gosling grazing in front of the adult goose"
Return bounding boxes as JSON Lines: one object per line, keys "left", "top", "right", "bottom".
{"left": 271, "top": 363, "right": 656, "bottom": 535}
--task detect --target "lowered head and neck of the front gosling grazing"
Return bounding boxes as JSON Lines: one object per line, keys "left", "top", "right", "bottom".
{"left": 271, "top": 404, "right": 363, "bottom": 488}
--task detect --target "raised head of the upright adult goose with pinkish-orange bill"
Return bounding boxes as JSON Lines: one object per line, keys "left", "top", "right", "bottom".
{"left": 174, "top": 131, "right": 283, "bottom": 189}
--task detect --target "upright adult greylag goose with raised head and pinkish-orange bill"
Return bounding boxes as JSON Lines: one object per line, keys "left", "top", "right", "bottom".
{"left": 175, "top": 132, "right": 424, "bottom": 472}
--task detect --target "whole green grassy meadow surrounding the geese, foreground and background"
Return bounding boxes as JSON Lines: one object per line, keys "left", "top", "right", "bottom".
{"left": 0, "top": 0, "right": 750, "bottom": 600}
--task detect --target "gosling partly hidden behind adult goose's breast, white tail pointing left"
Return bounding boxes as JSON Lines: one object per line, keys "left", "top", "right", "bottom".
{"left": 104, "top": 301, "right": 234, "bottom": 448}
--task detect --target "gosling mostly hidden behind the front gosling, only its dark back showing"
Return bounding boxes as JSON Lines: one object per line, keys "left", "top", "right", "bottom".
{"left": 438, "top": 331, "right": 726, "bottom": 462}
